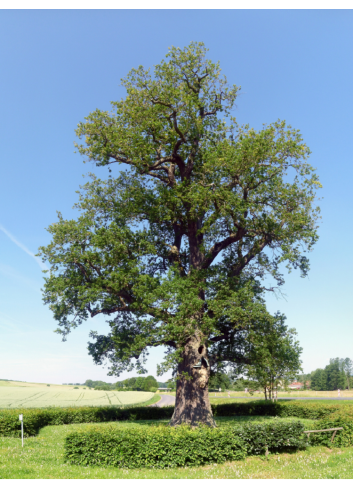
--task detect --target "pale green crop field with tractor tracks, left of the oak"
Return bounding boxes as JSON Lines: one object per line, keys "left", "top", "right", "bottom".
{"left": 0, "top": 384, "right": 154, "bottom": 409}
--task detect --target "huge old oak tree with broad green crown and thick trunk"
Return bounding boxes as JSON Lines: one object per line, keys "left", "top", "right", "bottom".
{"left": 41, "top": 43, "right": 320, "bottom": 425}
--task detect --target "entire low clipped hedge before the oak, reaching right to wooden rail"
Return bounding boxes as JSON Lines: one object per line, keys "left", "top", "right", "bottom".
{"left": 65, "top": 421, "right": 307, "bottom": 468}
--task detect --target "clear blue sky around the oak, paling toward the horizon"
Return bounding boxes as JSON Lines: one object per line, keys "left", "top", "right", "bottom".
{"left": 0, "top": 10, "right": 353, "bottom": 383}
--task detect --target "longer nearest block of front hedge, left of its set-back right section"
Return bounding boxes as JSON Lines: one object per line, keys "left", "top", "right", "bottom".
{"left": 65, "top": 426, "right": 246, "bottom": 468}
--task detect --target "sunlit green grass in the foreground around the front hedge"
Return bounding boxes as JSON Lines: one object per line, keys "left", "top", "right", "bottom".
{"left": 0, "top": 417, "right": 353, "bottom": 479}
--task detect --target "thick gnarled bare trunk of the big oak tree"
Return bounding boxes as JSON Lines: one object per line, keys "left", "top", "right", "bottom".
{"left": 170, "top": 338, "right": 216, "bottom": 427}
